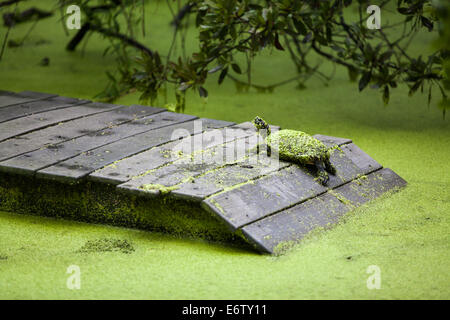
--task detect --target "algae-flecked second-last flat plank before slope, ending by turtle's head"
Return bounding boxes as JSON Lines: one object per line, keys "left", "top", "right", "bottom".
{"left": 118, "top": 125, "right": 282, "bottom": 196}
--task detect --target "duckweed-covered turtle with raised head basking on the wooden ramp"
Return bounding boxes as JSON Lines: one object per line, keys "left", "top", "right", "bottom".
{"left": 253, "top": 116, "right": 336, "bottom": 186}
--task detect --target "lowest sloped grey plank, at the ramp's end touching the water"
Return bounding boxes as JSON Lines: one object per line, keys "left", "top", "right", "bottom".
{"left": 242, "top": 168, "right": 406, "bottom": 253}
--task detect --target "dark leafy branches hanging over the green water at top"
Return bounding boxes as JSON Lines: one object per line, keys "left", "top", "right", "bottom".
{"left": 2, "top": 0, "right": 450, "bottom": 115}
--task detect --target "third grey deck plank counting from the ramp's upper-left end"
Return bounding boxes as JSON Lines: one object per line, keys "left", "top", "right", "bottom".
{"left": 0, "top": 103, "right": 120, "bottom": 141}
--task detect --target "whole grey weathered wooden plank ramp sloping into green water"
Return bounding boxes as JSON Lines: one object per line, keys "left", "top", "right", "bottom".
{"left": 0, "top": 91, "right": 406, "bottom": 253}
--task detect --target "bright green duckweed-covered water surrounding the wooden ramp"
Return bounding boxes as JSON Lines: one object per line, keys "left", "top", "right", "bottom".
{"left": 0, "top": 1, "right": 450, "bottom": 299}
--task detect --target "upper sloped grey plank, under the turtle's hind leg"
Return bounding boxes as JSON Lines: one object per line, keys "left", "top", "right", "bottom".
{"left": 200, "top": 139, "right": 381, "bottom": 228}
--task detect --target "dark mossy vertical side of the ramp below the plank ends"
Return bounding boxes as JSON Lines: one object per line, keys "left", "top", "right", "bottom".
{"left": 0, "top": 173, "right": 253, "bottom": 246}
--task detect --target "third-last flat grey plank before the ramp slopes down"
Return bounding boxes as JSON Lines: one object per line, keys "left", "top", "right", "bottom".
{"left": 89, "top": 119, "right": 244, "bottom": 184}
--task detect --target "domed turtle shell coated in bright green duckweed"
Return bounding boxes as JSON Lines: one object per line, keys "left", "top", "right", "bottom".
{"left": 266, "top": 129, "right": 330, "bottom": 164}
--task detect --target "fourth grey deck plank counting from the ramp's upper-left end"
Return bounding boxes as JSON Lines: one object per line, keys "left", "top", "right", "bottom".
{"left": 0, "top": 105, "right": 165, "bottom": 161}
